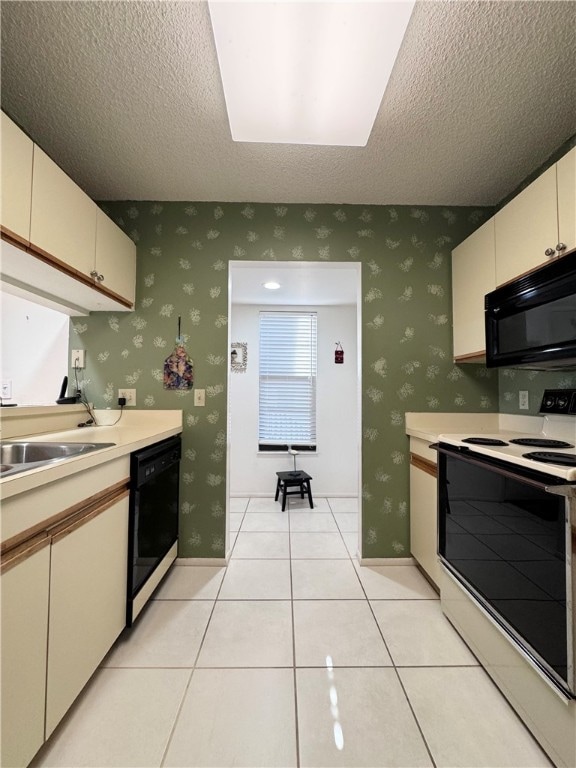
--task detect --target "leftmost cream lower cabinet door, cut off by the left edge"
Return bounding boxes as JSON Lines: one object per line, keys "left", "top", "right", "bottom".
{"left": 0, "top": 540, "right": 50, "bottom": 766}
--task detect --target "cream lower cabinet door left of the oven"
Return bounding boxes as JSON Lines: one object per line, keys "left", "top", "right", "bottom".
{"left": 410, "top": 465, "right": 440, "bottom": 586}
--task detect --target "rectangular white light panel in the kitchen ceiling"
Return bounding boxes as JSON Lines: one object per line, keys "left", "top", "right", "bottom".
{"left": 208, "top": 0, "right": 414, "bottom": 147}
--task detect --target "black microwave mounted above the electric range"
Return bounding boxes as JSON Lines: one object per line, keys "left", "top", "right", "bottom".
{"left": 485, "top": 249, "right": 576, "bottom": 370}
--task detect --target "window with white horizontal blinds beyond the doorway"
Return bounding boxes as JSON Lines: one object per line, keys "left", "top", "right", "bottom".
{"left": 258, "top": 312, "right": 317, "bottom": 451}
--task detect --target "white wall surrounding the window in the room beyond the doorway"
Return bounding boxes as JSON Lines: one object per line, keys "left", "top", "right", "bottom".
{"left": 228, "top": 304, "right": 359, "bottom": 497}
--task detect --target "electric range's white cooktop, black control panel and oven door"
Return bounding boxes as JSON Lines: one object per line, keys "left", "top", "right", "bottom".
{"left": 437, "top": 389, "right": 576, "bottom": 699}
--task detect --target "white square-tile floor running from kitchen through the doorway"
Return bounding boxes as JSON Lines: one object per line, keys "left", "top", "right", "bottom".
{"left": 33, "top": 498, "right": 550, "bottom": 768}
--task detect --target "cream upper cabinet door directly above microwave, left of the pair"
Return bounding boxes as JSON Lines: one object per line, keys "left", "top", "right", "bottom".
{"left": 495, "top": 165, "right": 558, "bottom": 285}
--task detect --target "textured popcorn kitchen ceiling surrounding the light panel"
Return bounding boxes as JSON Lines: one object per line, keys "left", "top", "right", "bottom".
{"left": 0, "top": 0, "right": 576, "bottom": 205}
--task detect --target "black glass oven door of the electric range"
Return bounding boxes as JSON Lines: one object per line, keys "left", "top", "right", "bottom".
{"left": 438, "top": 444, "right": 576, "bottom": 697}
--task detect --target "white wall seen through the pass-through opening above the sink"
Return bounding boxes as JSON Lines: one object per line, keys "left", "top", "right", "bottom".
{"left": 0, "top": 291, "right": 70, "bottom": 405}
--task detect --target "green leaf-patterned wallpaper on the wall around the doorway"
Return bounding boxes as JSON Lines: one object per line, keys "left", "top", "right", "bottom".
{"left": 70, "top": 202, "right": 498, "bottom": 557}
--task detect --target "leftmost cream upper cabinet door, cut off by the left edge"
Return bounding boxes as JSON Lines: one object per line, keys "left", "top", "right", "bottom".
{"left": 1, "top": 112, "right": 34, "bottom": 243}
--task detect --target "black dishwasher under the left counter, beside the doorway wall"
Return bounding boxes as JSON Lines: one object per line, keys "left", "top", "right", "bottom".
{"left": 126, "top": 436, "right": 182, "bottom": 627}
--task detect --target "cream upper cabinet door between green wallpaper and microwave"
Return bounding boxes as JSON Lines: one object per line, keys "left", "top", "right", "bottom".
{"left": 452, "top": 218, "right": 496, "bottom": 358}
